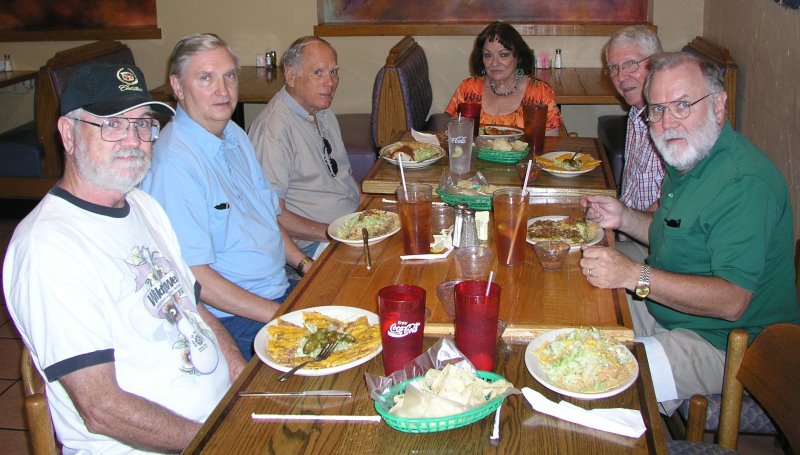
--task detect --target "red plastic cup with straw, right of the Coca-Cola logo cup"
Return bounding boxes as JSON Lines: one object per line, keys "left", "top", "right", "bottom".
{"left": 455, "top": 280, "right": 500, "bottom": 371}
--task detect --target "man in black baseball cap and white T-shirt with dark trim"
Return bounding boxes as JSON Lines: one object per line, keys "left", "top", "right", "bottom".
{"left": 3, "top": 64, "right": 244, "bottom": 453}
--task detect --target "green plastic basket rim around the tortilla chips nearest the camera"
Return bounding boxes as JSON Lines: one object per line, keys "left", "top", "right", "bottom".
{"left": 375, "top": 371, "right": 505, "bottom": 433}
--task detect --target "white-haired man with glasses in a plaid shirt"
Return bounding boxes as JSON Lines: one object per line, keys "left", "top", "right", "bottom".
{"left": 603, "top": 25, "right": 666, "bottom": 262}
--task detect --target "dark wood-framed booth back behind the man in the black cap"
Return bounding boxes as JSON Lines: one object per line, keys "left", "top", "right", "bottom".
{"left": 0, "top": 41, "right": 135, "bottom": 199}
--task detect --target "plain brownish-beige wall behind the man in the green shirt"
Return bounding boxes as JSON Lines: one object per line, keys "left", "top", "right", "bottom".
{"left": 704, "top": 0, "right": 800, "bottom": 238}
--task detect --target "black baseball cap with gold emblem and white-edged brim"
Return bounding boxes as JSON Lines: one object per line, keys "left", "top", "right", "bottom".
{"left": 61, "top": 63, "right": 175, "bottom": 117}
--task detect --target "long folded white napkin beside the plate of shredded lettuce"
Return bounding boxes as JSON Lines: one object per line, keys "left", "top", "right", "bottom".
{"left": 522, "top": 387, "right": 647, "bottom": 438}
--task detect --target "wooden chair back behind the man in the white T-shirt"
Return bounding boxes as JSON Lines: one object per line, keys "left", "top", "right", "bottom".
{"left": 20, "top": 346, "right": 58, "bottom": 455}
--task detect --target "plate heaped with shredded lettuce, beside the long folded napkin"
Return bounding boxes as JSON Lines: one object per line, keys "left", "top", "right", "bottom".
{"left": 525, "top": 327, "right": 639, "bottom": 400}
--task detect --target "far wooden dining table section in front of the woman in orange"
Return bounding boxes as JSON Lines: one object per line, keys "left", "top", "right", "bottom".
{"left": 361, "top": 136, "right": 617, "bottom": 197}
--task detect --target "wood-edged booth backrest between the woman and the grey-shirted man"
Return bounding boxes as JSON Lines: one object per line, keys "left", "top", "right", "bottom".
{"left": 372, "top": 36, "right": 433, "bottom": 147}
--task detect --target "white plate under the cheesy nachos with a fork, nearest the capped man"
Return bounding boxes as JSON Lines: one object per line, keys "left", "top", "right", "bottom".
{"left": 254, "top": 306, "right": 383, "bottom": 376}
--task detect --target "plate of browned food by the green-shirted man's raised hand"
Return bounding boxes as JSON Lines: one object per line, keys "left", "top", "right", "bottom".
{"left": 525, "top": 215, "right": 604, "bottom": 250}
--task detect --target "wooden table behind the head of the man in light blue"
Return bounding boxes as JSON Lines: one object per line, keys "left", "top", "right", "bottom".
{"left": 150, "top": 66, "right": 284, "bottom": 128}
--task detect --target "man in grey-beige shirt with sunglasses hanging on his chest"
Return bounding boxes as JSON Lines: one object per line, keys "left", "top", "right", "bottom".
{"left": 249, "top": 36, "right": 360, "bottom": 266}
